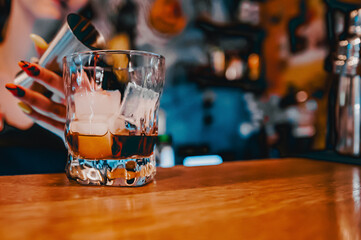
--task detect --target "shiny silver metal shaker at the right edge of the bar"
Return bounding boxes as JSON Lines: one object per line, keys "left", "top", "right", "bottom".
{"left": 333, "top": 9, "right": 361, "bottom": 156}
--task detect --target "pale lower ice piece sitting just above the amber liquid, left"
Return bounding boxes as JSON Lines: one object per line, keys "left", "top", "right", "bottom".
{"left": 70, "top": 121, "right": 108, "bottom": 136}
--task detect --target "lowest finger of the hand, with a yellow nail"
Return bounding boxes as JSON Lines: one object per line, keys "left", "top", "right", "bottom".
{"left": 18, "top": 102, "right": 65, "bottom": 139}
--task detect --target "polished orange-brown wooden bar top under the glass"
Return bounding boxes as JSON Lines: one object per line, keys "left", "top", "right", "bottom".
{"left": 0, "top": 159, "right": 361, "bottom": 240}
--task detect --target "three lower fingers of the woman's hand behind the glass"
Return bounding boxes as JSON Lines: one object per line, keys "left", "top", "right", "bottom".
{"left": 6, "top": 61, "right": 66, "bottom": 140}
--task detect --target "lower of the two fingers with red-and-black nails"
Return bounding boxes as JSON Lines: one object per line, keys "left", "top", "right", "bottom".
{"left": 5, "top": 83, "right": 66, "bottom": 121}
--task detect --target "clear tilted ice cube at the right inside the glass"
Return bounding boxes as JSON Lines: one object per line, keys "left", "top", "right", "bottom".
{"left": 120, "top": 83, "right": 159, "bottom": 128}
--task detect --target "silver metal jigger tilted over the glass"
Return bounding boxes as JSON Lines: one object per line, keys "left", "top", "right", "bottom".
{"left": 14, "top": 13, "right": 105, "bottom": 87}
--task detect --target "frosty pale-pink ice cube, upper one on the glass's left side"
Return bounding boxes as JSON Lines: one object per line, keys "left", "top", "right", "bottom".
{"left": 74, "top": 90, "right": 120, "bottom": 120}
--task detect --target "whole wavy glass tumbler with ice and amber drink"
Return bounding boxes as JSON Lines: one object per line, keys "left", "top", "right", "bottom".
{"left": 63, "top": 50, "right": 165, "bottom": 186}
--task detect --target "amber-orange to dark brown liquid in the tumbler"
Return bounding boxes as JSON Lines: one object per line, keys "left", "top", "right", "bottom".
{"left": 66, "top": 132, "right": 157, "bottom": 160}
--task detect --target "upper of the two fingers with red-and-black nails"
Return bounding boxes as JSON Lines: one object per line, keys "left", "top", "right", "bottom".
{"left": 18, "top": 61, "right": 65, "bottom": 98}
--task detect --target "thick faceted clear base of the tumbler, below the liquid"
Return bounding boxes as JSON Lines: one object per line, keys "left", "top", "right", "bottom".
{"left": 65, "top": 154, "right": 156, "bottom": 187}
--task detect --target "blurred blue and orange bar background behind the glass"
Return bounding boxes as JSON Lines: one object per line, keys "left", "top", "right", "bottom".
{"left": 0, "top": 0, "right": 361, "bottom": 172}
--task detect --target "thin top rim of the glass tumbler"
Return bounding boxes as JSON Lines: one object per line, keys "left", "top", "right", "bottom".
{"left": 64, "top": 49, "right": 165, "bottom": 60}
